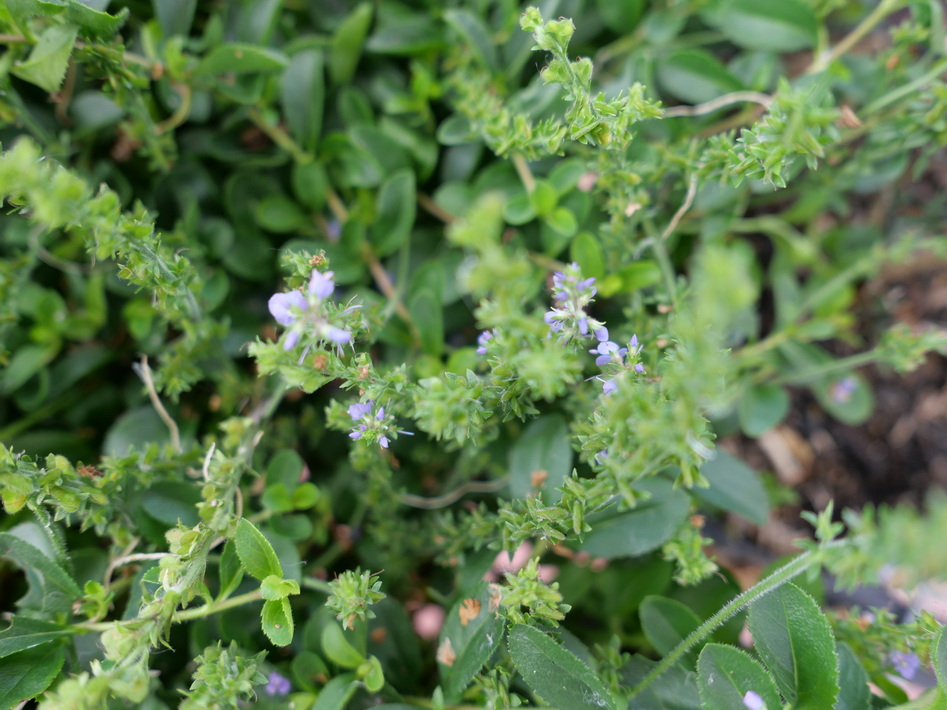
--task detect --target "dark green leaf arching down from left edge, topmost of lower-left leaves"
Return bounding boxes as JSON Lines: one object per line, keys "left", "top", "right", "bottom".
{"left": 0, "top": 533, "right": 82, "bottom": 614}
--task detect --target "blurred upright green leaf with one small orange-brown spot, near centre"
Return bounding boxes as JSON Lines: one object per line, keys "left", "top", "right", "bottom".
{"left": 509, "top": 414, "right": 572, "bottom": 503}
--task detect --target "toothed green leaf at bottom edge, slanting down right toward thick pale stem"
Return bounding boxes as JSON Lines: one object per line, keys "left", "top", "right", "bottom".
{"left": 509, "top": 624, "right": 618, "bottom": 710}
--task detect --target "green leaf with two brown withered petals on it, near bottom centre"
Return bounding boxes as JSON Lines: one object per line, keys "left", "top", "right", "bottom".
{"left": 437, "top": 583, "right": 503, "bottom": 702}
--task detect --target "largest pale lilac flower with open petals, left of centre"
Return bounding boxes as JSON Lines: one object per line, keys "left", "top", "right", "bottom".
{"left": 268, "top": 269, "right": 357, "bottom": 353}
